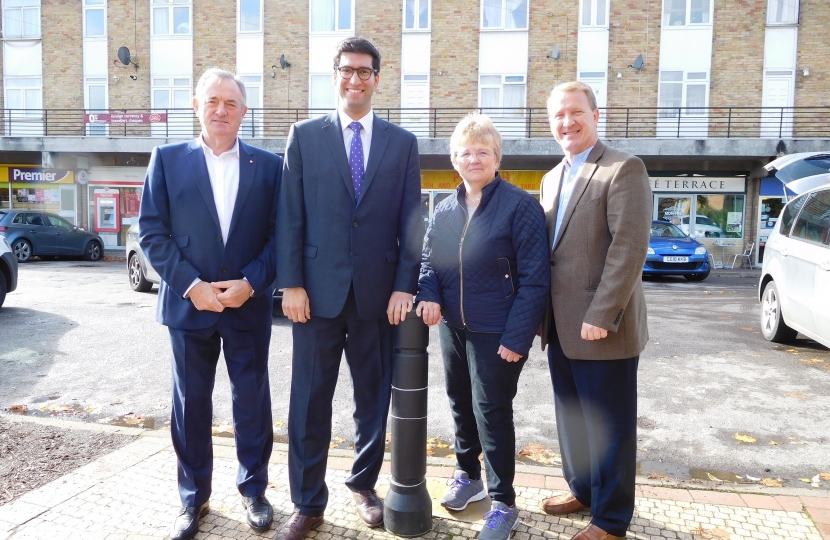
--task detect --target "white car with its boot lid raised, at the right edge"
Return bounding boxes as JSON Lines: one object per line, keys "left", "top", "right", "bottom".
{"left": 758, "top": 184, "right": 830, "bottom": 347}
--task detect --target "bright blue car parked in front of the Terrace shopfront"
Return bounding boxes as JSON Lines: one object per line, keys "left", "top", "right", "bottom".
{"left": 643, "top": 220, "right": 710, "bottom": 281}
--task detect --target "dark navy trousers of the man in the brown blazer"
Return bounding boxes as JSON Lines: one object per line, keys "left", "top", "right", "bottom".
{"left": 548, "top": 327, "right": 640, "bottom": 536}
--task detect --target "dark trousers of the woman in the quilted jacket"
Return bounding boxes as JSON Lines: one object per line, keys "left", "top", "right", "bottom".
{"left": 438, "top": 323, "right": 525, "bottom": 506}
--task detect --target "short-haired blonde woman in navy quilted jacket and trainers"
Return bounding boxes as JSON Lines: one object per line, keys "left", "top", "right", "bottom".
{"left": 416, "top": 114, "right": 550, "bottom": 540}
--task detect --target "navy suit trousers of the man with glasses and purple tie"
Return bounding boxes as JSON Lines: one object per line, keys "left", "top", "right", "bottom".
{"left": 288, "top": 290, "right": 392, "bottom": 516}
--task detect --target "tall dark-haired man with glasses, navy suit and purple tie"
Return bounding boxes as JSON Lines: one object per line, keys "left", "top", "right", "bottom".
{"left": 276, "top": 38, "right": 424, "bottom": 539}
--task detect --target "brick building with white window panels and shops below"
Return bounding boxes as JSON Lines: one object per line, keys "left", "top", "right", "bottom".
{"left": 0, "top": 0, "right": 830, "bottom": 266}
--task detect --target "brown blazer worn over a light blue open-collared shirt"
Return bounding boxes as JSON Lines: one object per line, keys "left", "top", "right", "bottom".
{"left": 541, "top": 142, "right": 652, "bottom": 360}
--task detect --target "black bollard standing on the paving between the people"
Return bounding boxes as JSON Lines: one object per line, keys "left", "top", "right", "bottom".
{"left": 383, "top": 310, "right": 432, "bottom": 537}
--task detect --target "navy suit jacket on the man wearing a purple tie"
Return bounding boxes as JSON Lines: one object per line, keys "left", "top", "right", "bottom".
{"left": 277, "top": 111, "right": 424, "bottom": 320}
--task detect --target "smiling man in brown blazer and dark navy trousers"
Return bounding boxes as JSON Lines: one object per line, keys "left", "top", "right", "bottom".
{"left": 542, "top": 82, "right": 652, "bottom": 540}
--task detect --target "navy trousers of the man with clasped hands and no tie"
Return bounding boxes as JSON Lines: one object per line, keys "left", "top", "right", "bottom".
{"left": 169, "top": 318, "right": 274, "bottom": 506}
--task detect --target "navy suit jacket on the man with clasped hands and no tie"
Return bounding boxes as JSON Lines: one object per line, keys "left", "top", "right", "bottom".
{"left": 138, "top": 139, "right": 282, "bottom": 330}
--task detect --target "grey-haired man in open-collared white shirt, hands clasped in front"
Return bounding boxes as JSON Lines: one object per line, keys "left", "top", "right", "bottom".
{"left": 138, "top": 69, "right": 282, "bottom": 540}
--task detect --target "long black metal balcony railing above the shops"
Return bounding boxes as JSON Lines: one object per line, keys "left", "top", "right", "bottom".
{"left": 0, "top": 106, "right": 830, "bottom": 139}
